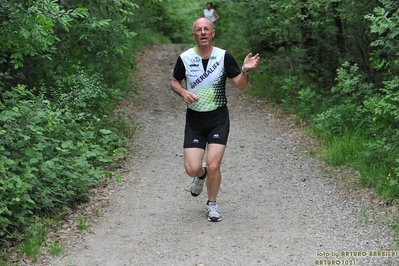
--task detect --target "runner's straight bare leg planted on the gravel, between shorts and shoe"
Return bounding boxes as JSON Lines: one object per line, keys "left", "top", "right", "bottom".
{"left": 206, "top": 144, "right": 226, "bottom": 201}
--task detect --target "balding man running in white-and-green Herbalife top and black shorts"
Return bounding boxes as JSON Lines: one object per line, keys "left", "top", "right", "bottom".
{"left": 171, "top": 18, "right": 260, "bottom": 222}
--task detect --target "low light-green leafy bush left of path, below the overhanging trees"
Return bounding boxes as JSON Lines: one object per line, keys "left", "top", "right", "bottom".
{"left": 0, "top": 86, "right": 124, "bottom": 241}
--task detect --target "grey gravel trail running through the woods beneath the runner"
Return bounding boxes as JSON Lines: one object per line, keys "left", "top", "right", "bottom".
{"left": 47, "top": 45, "right": 399, "bottom": 266}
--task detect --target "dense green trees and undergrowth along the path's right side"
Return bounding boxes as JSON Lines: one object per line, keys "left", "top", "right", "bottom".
{"left": 218, "top": 0, "right": 399, "bottom": 200}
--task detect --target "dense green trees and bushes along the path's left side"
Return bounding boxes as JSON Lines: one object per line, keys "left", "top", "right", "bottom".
{"left": 0, "top": 0, "right": 167, "bottom": 247}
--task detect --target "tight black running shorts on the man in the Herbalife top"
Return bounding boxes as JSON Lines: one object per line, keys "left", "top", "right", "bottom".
{"left": 184, "top": 106, "right": 230, "bottom": 150}
